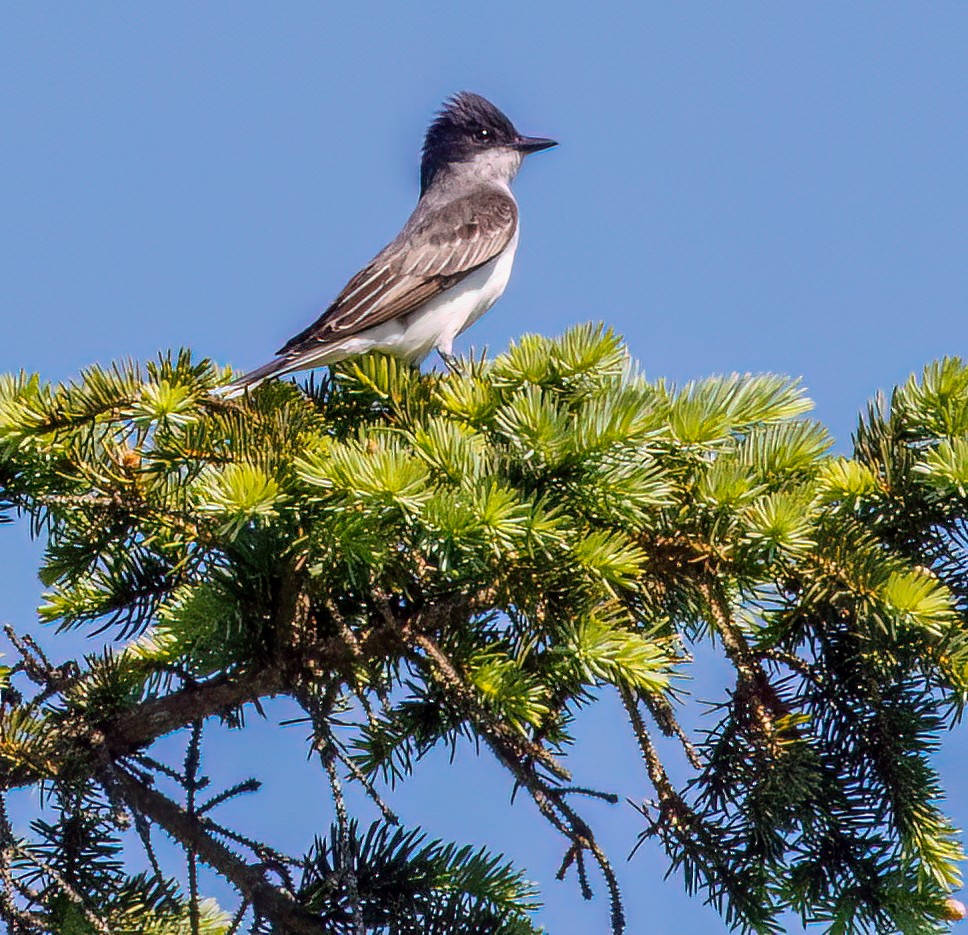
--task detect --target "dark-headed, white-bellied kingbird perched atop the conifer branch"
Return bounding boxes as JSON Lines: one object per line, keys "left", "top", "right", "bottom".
{"left": 229, "top": 91, "right": 556, "bottom": 390}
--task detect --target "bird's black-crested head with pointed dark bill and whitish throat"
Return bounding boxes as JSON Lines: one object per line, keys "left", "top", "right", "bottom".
{"left": 420, "top": 91, "right": 557, "bottom": 194}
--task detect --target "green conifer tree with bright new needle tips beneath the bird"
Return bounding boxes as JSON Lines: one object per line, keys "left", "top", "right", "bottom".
{"left": 0, "top": 326, "right": 968, "bottom": 935}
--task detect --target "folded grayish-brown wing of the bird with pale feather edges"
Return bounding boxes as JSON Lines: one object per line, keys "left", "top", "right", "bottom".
{"left": 277, "top": 188, "right": 518, "bottom": 357}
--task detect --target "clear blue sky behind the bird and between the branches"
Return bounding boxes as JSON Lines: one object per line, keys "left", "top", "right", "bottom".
{"left": 0, "top": 0, "right": 968, "bottom": 935}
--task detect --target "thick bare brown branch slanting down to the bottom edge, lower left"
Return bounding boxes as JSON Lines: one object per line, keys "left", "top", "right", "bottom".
{"left": 106, "top": 769, "right": 325, "bottom": 935}
